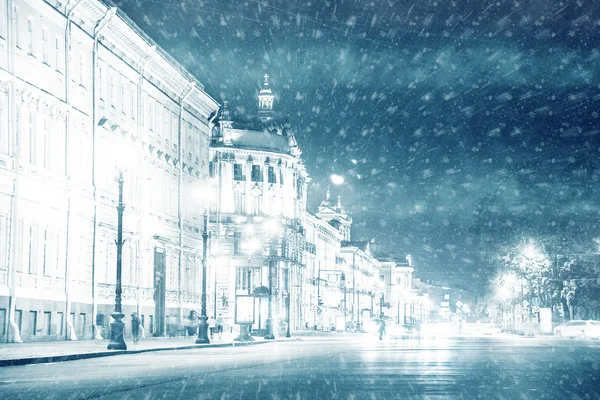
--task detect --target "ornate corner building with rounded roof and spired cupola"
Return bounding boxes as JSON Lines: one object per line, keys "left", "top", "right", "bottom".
{"left": 209, "top": 75, "right": 309, "bottom": 334}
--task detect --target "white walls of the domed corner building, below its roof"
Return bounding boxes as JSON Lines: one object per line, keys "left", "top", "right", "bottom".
{"left": 207, "top": 143, "right": 307, "bottom": 334}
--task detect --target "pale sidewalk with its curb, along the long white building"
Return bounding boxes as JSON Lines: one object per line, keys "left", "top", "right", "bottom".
{"left": 0, "top": 333, "right": 300, "bottom": 367}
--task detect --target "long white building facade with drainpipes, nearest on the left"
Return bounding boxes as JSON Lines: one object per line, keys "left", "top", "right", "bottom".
{"left": 0, "top": 0, "right": 218, "bottom": 341}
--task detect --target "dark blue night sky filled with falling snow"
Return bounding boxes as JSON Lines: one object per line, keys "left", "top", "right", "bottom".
{"left": 113, "top": 0, "right": 600, "bottom": 294}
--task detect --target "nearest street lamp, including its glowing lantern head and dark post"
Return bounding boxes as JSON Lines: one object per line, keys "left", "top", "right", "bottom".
{"left": 108, "top": 132, "right": 129, "bottom": 350}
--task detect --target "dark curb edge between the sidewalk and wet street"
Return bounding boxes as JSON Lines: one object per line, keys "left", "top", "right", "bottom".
{"left": 0, "top": 338, "right": 302, "bottom": 368}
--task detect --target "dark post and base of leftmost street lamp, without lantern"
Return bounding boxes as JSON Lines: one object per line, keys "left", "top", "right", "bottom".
{"left": 108, "top": 170, "right": 127, "bottom": 350}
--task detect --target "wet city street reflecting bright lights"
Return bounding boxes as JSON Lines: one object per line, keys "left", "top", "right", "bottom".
{"left": 0, "top": 334, "right": 600, "bottom": 399}
